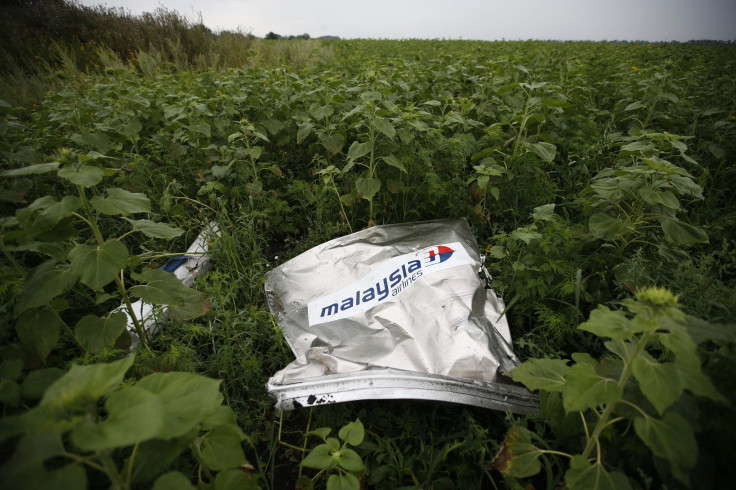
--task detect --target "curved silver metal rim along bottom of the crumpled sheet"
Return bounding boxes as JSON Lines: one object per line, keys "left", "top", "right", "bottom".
{"left": 266, "top": 369, "right": 539, "bottom": 414}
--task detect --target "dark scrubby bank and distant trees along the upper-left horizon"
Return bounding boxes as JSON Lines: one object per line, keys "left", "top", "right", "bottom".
{"left": 0, "top": 0, "right": 336, "bottom": 73}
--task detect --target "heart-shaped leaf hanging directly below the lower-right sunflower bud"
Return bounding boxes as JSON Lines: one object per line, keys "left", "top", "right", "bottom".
{"left": 632, "top": 354, "right": 685, "bottom": 414}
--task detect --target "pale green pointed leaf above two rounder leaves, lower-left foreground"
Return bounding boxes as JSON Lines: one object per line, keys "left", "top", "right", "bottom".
{"left": 39, "top": 356, "right": 135, "bottom": 414}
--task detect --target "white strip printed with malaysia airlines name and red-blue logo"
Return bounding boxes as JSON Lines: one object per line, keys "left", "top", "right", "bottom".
{"left": 307, "top": 242, "right": 478, "bottom": 325}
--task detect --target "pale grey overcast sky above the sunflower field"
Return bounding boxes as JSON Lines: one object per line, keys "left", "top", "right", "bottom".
{"left": 80, "top": 0, "right": 736, "bottom": 41}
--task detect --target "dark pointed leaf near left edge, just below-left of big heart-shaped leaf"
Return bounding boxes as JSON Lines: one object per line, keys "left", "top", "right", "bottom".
{"left": 15, "top": 260, "right": 77, "bottom": 316}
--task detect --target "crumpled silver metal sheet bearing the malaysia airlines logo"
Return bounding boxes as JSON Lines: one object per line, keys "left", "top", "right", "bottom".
{"left": 265, "top": 219, "right": 538, "bottom": 413}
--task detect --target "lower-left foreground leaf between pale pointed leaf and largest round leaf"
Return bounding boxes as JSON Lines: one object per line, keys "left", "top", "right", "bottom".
{"left": 71, "top": 385, "right": 168, "bottom": 451}
